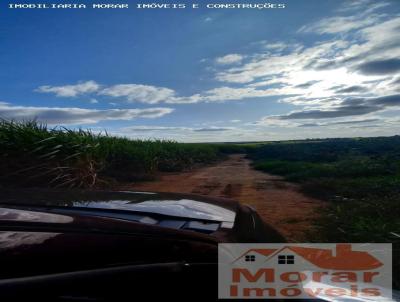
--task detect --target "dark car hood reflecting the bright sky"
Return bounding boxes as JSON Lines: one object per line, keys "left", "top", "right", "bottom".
{"left": 0, "top": 190, "right": 237, "bottom": 223}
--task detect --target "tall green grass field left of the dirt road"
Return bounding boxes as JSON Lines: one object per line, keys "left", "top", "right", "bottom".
{"left": 0, "top": 120, "right": 221, "bottom": 188}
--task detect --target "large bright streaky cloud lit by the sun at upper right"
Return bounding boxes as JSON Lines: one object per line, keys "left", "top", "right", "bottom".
{"left": 209, "top": 17, "right": 400, "bottom": 108}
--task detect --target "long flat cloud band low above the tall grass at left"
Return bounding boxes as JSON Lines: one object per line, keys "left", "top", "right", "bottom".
{"left": 0, "top": 103, "right": 173, "bottom": 125}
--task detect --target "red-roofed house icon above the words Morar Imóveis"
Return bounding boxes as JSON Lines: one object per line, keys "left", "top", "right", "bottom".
{"left": 233, "top": 243, "right": 383, "bottom": 271}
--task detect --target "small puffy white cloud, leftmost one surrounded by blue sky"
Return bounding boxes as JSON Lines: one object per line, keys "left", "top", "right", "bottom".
{"left": 36, "top": 81, "right": 100, "bottom": 97}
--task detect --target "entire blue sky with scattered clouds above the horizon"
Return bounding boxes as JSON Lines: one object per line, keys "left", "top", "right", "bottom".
{"left": 0, "top": 0, "right": 400, "bottom": 142}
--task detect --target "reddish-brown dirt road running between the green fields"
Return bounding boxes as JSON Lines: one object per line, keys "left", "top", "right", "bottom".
{"left": 125, "top": 154, "right": 325, "bottom": 242}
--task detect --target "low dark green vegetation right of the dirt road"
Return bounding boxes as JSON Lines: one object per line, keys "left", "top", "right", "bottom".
{"left": 249, "top": 136, "right": 400, "bottom": 242}
